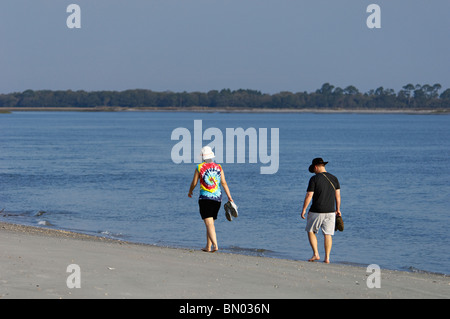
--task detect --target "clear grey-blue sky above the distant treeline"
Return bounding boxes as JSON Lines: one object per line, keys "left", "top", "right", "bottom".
{"left": 0, "top": 0, "right": 450, "bottom": 93}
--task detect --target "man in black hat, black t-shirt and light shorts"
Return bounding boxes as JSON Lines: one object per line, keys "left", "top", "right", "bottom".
{"left": 301, "top": 158, "right": 341, "bottom": 264}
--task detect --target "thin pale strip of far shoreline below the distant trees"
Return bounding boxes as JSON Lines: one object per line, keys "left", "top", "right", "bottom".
{"left": 0, "top": 106, "right": 450, "bottom": 115}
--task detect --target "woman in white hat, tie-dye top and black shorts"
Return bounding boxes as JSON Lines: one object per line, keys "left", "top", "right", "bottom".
{"left": 188, "top": 146, "right": 233, "bottom": 252}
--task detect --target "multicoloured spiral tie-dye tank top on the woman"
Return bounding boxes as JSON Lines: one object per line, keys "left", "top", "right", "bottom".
{"left": 197, "top": 162, "right": 222, "bottom": 202}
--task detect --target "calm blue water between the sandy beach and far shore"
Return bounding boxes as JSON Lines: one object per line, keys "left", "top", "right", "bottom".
{"left": 0, "top": 112, "right": 450, "bottom": 274}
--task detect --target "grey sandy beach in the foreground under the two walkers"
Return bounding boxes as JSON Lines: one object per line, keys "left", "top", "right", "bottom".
{"left": 0, "top": 223, "right": 450, "bottom": 299}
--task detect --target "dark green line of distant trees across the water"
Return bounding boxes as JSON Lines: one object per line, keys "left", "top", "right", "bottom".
{"left": 0, "top": 83, "right": 450, "bottom": 109}
